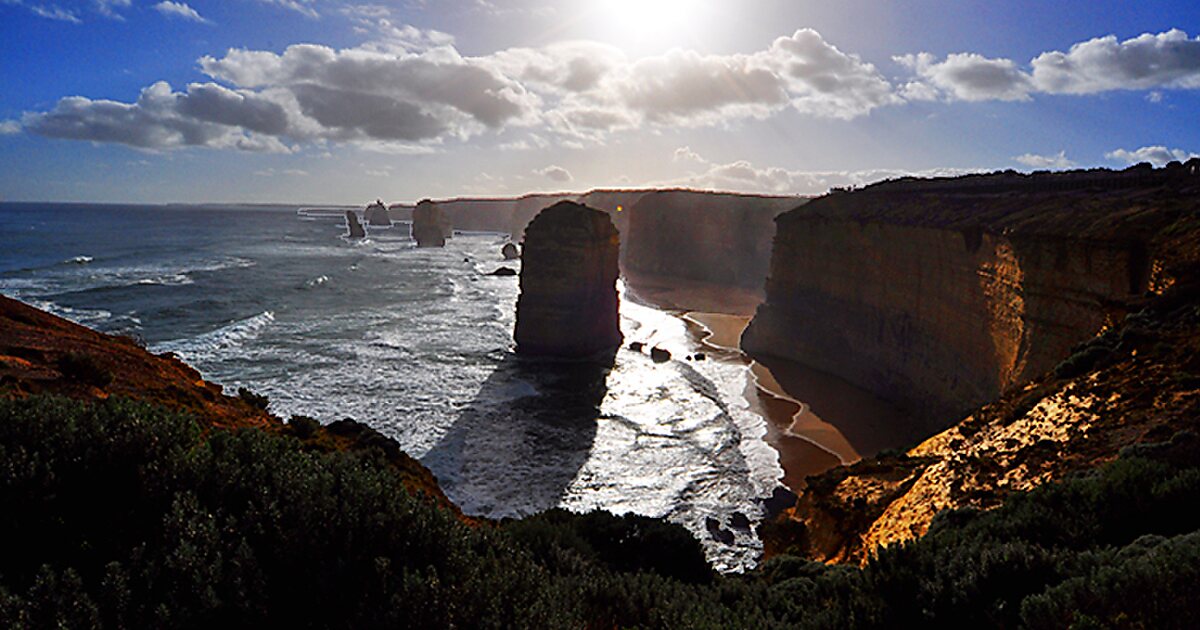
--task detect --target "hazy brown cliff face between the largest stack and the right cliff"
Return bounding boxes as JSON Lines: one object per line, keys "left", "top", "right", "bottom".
{"left": 622, "top": 191, "right": 804, "bottom": 292}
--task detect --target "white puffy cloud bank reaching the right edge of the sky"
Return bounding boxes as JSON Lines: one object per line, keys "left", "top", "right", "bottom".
{"left": 893, "top": 29, "right": 1200, "bottom": 102}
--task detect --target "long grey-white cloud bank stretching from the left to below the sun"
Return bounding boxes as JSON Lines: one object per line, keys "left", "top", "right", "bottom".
{"left": 16, "top": 27, "right": 902, "bottom": 152}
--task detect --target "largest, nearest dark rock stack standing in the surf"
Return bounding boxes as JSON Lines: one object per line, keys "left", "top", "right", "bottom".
{"left": 514, "top": 202, "right": 622, "bottom": 359}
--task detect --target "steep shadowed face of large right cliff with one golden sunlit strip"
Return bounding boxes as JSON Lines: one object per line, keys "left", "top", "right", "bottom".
{"left": 743, "top": 166, "right": 1186, "bottom": 427}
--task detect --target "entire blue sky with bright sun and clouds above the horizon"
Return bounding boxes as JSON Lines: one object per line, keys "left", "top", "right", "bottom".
{"left": 0, "top": 0, "right": 1200, "bottom": 204}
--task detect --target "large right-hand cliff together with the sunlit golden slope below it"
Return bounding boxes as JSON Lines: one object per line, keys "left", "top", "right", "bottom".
{"left": 743, "top": 168, "right": 1200, "bottom": 563}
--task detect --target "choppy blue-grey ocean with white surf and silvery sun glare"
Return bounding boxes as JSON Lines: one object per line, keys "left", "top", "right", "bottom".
{"left": 0, "top": 204, "right": 784, "bottom": 571}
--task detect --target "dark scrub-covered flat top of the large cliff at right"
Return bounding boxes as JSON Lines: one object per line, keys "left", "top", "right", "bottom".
{"left": 779, "top": 158, "right": 1200, "bottom": 242}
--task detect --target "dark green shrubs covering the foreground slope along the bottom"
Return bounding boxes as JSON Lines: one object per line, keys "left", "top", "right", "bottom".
{"left": 0, "top": 396, "right": 1200, "bottom": 628}
